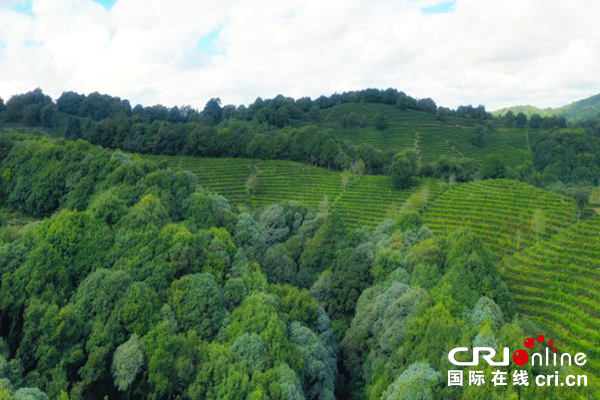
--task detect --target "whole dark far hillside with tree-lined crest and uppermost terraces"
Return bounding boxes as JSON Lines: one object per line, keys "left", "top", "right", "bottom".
{"left": 0, "top": 89, "right": 600, "bottom": 202}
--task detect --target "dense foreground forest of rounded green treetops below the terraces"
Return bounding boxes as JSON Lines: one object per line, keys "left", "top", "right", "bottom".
{"left": 0, "top": 136, "right": 585, "bottom": 400}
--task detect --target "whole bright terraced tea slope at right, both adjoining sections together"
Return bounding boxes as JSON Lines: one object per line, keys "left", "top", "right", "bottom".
{"left": 425, "top": 180, "right": 600, "bottom": 378}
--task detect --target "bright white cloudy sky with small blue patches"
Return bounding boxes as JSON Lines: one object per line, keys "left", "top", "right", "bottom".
{"left": 0, "top": 0, "right": 600, "bottom": 110}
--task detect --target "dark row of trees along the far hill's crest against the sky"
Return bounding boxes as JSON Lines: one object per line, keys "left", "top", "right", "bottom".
{"left": 0, "top": 88, "right": 490, "bottom": 128}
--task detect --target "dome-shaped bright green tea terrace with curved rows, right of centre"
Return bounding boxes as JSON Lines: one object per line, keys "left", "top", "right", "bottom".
{"left": 425, "top": 179, "right": 578, "bottom": 259}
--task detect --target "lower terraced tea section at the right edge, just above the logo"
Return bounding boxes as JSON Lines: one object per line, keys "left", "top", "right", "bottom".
{"left": 503, "top": 216, "right": 600, "bottom": 374}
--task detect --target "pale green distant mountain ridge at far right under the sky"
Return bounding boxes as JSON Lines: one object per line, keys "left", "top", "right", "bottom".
{"left": 492, "top": 94, "right": 600, "bottom": 123}
